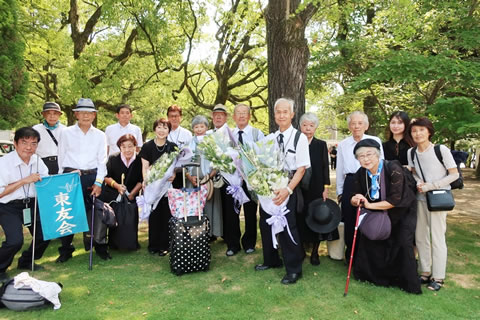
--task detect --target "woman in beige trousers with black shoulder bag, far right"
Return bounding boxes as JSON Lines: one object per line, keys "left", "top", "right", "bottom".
{"left": 408, "top": 118, "right": 459, "bottom": 291}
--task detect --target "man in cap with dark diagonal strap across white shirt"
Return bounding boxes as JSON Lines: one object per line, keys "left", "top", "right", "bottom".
{"left": 33, "top": 102, "right": 66, "bottom": 174}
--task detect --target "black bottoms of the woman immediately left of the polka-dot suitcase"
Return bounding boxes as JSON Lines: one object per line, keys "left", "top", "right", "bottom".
{"left": 148, "top": 197, "right": 172, "bottom": 251}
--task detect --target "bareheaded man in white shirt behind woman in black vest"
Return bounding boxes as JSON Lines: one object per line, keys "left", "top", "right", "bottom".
{"left": 105, "top": 104, "right": 143, "bottom": 156}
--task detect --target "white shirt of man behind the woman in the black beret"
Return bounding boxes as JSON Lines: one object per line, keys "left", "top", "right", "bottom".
{"left": 336, "top": 134, "right": 384, "bottom": 196}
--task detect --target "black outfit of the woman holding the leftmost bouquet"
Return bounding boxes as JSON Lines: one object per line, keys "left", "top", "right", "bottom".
{"left": 139, "top": 139, "right": 182, "bottom": 254}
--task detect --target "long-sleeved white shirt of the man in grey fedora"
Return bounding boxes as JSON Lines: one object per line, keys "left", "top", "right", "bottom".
{"left": 58, "top": 124, "right": 107, "bottom": 181}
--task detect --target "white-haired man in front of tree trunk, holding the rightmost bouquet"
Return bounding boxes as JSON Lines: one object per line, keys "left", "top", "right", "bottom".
{"left": 255, "top": 98, "right": 310, "bottom": 284}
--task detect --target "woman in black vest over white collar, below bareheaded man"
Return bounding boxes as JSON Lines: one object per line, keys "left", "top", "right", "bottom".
{"left": 100, "top": 134, "right": 143, "bottom": 249}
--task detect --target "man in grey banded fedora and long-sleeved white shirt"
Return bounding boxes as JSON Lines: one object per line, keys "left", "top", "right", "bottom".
{"left": 57, "top": 98, "right": 111, "bottom": 262}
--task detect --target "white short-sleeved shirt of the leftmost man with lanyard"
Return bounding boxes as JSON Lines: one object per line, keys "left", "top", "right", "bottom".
{"left": 0, "top": 150, "right": 48, "bottom": 203}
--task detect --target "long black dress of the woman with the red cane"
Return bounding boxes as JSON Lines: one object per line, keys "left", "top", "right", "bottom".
{"left": 350, "top": 161, "right": 422, "bottom": 294}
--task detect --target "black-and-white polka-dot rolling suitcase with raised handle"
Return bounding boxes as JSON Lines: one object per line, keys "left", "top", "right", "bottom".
{"left": 170, "top": 164, "right": 211, "bottom": 276}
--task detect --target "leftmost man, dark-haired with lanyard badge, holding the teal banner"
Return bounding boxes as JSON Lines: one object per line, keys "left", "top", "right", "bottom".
{"left": 0, "top": 127, "right": 49, "bottom": 280}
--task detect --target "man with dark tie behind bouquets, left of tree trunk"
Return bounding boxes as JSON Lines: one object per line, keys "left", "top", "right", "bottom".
{"left": 230, "top": 104, "right": 265, "bottom": 254}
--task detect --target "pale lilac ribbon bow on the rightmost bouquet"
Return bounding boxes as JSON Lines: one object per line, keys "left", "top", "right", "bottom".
{"left": 258, "top": 196, "right": 297, "bottom": 249}
